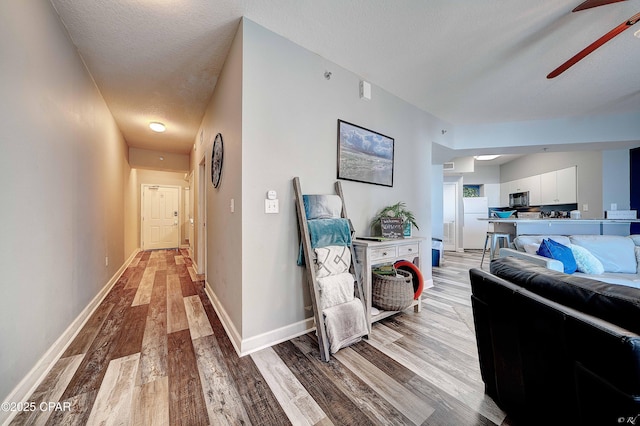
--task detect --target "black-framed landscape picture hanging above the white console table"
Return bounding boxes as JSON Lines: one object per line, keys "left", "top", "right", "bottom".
{"left": 337, "top": 119, "right": 395, "bottom": 187}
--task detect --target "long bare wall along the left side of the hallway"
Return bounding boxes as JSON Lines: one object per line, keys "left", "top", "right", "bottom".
{"left": 0, "top": 0, "right": 131, "bottom": 402}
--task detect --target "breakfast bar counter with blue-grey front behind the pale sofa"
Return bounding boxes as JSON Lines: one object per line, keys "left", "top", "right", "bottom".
{"left": 481, "top": 218, "right": 640, "bottom": 237}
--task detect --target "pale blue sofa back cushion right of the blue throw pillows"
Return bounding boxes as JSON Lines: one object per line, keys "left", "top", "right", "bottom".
{"left": 569, "top": 235, "right": 637, "bottom": 274}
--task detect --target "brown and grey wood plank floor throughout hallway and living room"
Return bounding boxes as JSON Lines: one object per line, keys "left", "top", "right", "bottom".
{"left": 11, "top": 250, "right": 509, "bottom": 425}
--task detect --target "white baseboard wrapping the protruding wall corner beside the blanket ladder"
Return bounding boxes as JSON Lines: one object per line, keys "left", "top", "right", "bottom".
{"left": 205, "top": 282, "right": 315, "bottom": 357}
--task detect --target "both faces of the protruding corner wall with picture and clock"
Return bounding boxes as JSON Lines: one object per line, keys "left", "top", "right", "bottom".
{"left": 203, "top": 19, "right": 447, "bottom": 350}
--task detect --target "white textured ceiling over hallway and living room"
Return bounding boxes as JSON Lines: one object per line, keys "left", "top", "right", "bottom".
{"left": 51, "top": 0, "right": 640, "bottom": 153}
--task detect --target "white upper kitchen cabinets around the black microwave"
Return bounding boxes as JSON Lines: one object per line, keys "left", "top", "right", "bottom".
{"left": 500, "top": 166, "right": 578, "bottom": 206}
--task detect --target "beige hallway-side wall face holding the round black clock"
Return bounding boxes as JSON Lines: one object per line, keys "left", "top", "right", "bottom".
{"left": 192, "top": 23, "right": 244, "bottom": 341}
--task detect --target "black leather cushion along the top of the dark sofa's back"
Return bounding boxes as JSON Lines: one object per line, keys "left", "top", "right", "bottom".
{"left": 491, "top": 257, "right": 640, "bottom": 333}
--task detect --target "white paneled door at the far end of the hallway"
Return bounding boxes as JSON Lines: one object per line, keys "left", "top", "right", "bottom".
{"left": 142, "top": 185, "right": 180, "bottom": 250}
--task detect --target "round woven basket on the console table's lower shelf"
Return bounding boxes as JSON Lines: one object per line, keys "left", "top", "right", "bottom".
{"left": 371, "top": 269, "right": 414, "bottom": 311}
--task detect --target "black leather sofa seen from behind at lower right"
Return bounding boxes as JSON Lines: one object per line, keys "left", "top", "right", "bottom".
{"left": 469, "top": 257, "right": 640, "bottom": 425}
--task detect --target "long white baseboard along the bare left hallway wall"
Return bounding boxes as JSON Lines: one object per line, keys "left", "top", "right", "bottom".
{"left": 0, "top": 249, "right": 140, "bottom": 425}
